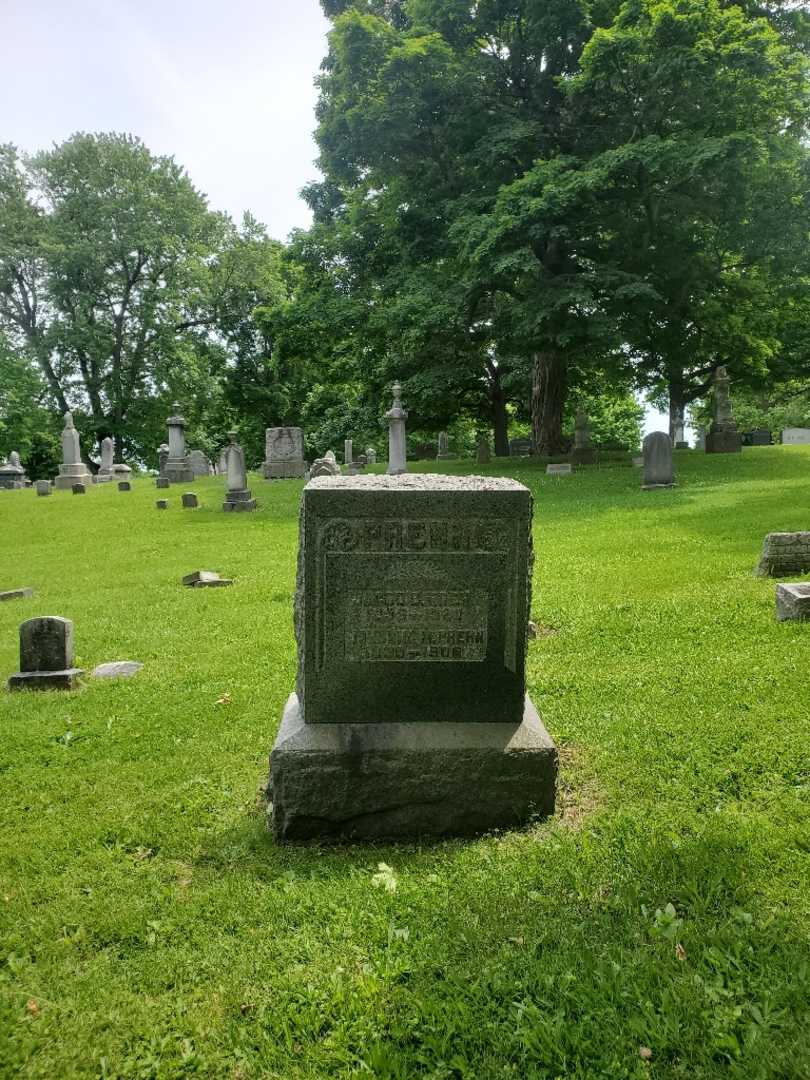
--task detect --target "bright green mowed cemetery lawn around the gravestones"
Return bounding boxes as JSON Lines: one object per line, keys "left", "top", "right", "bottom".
{"left": 0, "top": 447, "right": 810, "bottom": 1080}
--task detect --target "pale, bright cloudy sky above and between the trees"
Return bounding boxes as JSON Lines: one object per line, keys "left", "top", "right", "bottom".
{"left": 0, "top": 0, "right": 667, "bottom": 431}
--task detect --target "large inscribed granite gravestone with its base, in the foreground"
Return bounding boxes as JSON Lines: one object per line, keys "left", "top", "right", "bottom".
{"left": 270, "top": 474, "right": 556, "bottom": 840}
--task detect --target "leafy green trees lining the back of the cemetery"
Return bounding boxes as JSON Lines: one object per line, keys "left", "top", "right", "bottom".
{"left": 0, "top": 0, "right": 810, "bottom": 463}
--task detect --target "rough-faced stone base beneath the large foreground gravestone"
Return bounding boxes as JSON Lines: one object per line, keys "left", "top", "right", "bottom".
{"left": 268, "top": 693, "right": 557, "bottom": 842}
